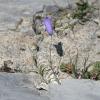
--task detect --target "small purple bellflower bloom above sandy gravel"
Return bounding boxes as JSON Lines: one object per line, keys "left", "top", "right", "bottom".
{"left": 43, "top": 17, "right": 53, "bottom": 36}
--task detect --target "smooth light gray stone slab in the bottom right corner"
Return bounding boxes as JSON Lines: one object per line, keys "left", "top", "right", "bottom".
{"left": 49, "top": 79, "right": 100, "bottom": 100}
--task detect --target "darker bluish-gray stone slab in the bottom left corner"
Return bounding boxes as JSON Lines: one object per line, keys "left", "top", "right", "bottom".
{"left": 0, "top": 73, "right": 49, "bottom": 100}
